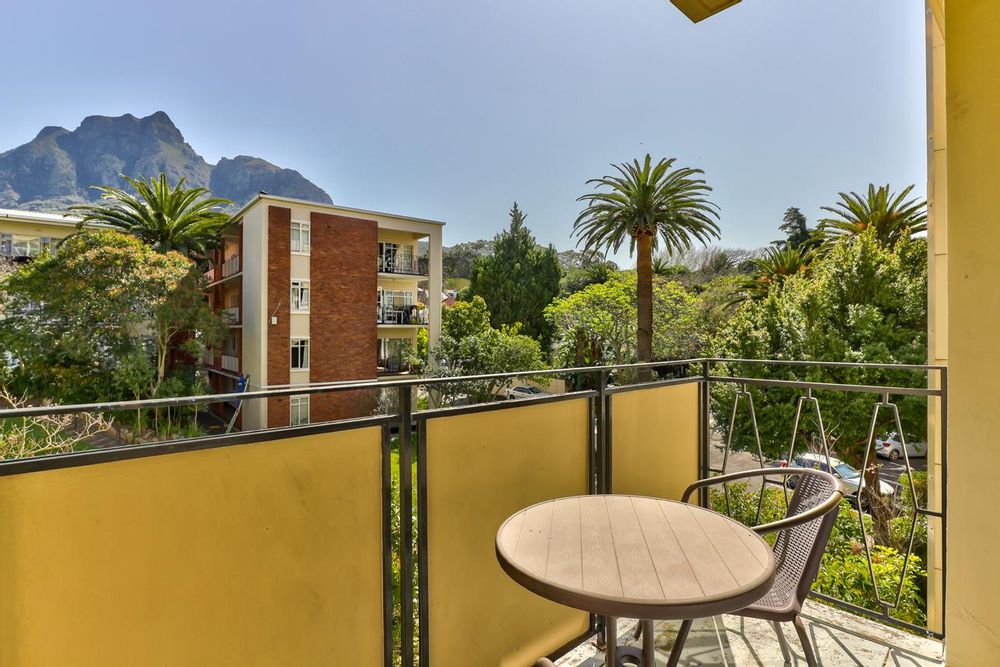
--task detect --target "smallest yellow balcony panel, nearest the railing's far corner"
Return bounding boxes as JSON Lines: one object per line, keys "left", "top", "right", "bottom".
{"left": 611, "top": 383, "right": 699, "bottom": 500}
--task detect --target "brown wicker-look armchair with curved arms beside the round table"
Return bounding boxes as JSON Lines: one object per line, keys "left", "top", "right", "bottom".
{"left": 640, "top": 468, "right": 844, "bottom": 667}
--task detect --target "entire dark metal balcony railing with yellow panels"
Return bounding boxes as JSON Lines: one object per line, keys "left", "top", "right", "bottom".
{"left": 0, "top": 359, "right": 948, "bottom": 667}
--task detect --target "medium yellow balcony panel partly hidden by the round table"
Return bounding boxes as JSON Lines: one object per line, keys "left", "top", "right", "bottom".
{"left": 427, "top": 398, "right": 590, "bottom": 667}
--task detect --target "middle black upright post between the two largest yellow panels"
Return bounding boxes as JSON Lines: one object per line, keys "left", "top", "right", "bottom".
{"left": 399, "top": 385, "right": 413, "bottom": 667}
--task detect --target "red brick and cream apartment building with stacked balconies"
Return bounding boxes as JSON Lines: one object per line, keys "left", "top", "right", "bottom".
{"left": 205, "top": 194, "right": 444, "bottom": 430}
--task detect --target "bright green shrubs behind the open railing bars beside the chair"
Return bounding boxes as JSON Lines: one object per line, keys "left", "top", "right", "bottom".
{"left": 709, "top": 482, "right": 927, "bottom": 625}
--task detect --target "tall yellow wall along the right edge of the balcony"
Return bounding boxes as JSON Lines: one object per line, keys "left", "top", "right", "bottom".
{"left": 934, "top": 0, "right": 1000, "bottom": 665}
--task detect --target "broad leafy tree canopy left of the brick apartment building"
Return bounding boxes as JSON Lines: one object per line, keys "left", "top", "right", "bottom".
{"left": 0, "top": 230, "right": 224, "bottom": 400}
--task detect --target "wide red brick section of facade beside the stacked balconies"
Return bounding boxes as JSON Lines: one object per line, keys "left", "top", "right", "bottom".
{"left": 310, "top": 212, "right": 378, "bottom": 422}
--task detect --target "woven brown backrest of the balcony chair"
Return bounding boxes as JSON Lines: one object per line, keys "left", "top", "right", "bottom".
{"left": 765, "top": 472, "right": 840, "bottom": 609}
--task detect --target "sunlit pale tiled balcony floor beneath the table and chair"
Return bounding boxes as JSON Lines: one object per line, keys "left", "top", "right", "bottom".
{"left": 556, "top": 602, "right": 944, "bottom": 667}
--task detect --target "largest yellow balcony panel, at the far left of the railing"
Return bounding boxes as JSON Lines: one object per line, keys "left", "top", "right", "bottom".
{"left": 0, "top": 428, "right": 383, "bottom": 667}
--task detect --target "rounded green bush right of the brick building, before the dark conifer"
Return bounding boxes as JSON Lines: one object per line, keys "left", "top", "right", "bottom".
{"left": 429, "top": 296, "right": 545, "bottom": 404}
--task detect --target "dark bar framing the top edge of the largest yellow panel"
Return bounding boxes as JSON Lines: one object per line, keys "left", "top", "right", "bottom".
{"left": 0, "top": 415, "right": 398, "bottom": 477}
